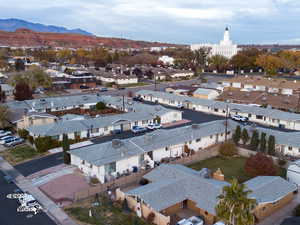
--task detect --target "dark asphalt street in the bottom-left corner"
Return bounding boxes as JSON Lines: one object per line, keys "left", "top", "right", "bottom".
{"left": 0, "top": 171, "right": 56, "bottom": 225}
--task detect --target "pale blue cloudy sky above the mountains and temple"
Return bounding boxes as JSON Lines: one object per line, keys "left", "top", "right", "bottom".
{"left": 0, "top": 0, "right": 300, "bottom": 44}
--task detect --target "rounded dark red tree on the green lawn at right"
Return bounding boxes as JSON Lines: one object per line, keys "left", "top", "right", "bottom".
{"left": 245, "top": 152, "right": 277, "bottom": 177}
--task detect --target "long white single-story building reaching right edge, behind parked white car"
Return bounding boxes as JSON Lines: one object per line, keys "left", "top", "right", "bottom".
{"left": 136, "top": 90, "right": 300, "bottom": 130}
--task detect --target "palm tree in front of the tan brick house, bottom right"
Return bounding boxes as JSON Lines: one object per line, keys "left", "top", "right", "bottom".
{"left": 216, "top": 179, "right": 256, "bottom": 225}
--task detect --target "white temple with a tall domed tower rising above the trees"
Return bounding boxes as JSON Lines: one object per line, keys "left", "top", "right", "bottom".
{"left": 191, "top": 27, "right": 239, "bottom": 59}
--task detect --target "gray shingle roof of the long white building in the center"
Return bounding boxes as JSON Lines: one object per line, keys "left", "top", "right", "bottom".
{"left": 70, "top": 120, "right": 236, "bottom": 166}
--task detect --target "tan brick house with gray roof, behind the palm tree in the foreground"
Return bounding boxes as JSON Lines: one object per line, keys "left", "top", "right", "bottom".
{"left": 117, "top": 164, "right": 297, "bottom": 225}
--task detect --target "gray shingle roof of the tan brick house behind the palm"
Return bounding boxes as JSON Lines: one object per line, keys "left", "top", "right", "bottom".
{"left": 126, "top": 164, "right": 297, "bottom": 215}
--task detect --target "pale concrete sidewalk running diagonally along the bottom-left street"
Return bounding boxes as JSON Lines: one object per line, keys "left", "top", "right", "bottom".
{"left": 0, "top": 157, "right": 78, "bottom": 225}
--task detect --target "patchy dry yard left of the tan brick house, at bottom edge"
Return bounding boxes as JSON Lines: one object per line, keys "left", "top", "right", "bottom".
{"left": 65, "top": 196, "right": 151, "bottom": 225}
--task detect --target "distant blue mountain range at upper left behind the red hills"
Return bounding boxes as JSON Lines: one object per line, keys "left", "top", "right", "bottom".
{"left": 0, "top": 18, "right": 93, "bottom": 35}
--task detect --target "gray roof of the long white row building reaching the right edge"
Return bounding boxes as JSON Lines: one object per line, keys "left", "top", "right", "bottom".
{"left": 136, "top": 90, "right": 300, "bottom": 121}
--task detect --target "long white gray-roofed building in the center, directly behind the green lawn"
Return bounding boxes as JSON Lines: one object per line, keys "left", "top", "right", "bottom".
{"left": 70, "top": 120, "right": 237, "bottom": 183}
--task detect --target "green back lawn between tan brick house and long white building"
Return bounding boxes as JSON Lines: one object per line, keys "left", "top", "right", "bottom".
{"left": 189, "top": 156, "right": 286, "bottom": 182}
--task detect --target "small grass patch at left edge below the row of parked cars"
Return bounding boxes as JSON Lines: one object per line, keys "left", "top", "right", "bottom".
{"left": 1, "top": 144, "right": 42, "bottom": 165}
